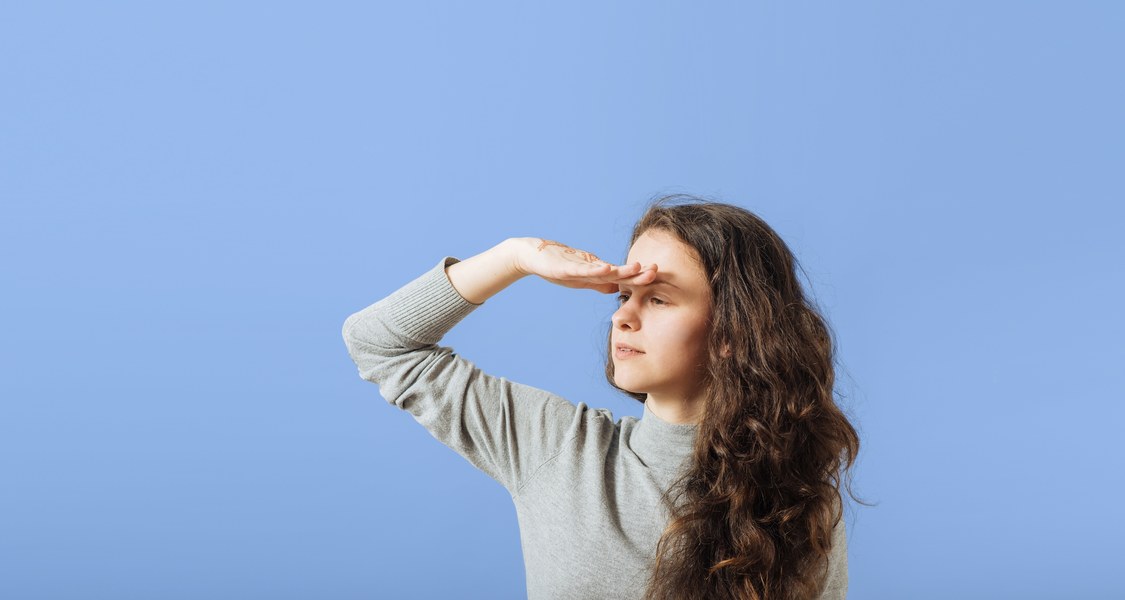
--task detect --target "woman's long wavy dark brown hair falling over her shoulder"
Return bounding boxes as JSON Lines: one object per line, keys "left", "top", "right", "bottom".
{"left": 605, "top": 194, "right": 863, "bottom": 600}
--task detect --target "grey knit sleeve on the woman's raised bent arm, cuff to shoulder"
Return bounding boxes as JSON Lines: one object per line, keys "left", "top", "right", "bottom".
{"left": 342, "top": 257, "right": 587, "bottom": 498}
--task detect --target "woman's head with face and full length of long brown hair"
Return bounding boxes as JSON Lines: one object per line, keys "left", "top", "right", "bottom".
{"left": 605, "top": 195, "right": 860, "bottom": 599}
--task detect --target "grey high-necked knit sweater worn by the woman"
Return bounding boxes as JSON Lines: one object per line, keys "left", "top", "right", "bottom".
{"left": 343, "top": 257, "right": 847, "bottom": 600}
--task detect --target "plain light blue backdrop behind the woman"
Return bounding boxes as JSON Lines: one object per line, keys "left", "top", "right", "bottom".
{"left": 0, "top": 1, "right": 1125, "bottom": 599}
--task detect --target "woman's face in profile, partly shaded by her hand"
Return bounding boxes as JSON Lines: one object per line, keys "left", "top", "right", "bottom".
{"left": 610, "top": 230, "right": 711, "bottom": 401}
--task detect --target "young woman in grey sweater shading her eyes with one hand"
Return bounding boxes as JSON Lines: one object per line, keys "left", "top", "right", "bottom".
{"left": 343, "top": 195, "right": 860, "bottom": 600}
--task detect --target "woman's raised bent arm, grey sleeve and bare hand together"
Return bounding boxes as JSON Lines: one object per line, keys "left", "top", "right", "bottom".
{"left": 342, "top": 238, "right": 650, "bottom": 496}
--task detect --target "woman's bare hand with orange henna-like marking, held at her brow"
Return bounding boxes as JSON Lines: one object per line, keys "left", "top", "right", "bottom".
{"left": 514, "top": 238, "right": 657, "bottom": 294}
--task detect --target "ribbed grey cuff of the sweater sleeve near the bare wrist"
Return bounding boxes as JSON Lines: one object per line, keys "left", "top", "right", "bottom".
{"left": 384, "top": 257, "right": 483, "bottom": 343}
